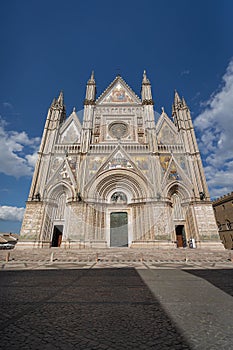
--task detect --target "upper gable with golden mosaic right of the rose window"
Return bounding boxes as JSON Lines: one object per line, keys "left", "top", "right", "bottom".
{"left": 156, "top": 111, "right": 180, "bottom": 145}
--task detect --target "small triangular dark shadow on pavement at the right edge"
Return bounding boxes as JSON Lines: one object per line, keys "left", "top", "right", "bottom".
{"left": 183, "top": 269, "right": 233, "bottom": 296}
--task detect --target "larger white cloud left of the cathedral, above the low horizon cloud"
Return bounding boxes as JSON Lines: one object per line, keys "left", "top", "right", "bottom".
{"left": 0, "top": 118, "right": 40, "bottom": 177}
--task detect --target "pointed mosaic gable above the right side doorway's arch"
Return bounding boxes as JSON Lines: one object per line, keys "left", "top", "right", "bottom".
{"left": 162, "top": 155, "right": 191, "bottom": 188}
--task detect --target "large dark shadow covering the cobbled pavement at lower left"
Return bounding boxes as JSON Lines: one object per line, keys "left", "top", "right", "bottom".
{"left": 0, "top": 268, "right": 191, "bottom": 350}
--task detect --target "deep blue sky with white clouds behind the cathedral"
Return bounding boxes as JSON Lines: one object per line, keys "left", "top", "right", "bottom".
{"left": 0, "top": 0, "right": 233, "bottom": 232}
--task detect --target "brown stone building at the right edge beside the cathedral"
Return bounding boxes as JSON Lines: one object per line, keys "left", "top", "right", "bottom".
{"left": 213, "top": 192, "right": 233, "bottom": 249}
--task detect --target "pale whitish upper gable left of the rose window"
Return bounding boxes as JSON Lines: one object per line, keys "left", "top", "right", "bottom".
{"left": 59, "top": 110, "right": 82, "bottom": 143}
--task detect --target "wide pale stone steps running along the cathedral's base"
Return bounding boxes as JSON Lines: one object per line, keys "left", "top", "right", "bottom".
{"left": 0, "top": 248, "right": 233, "bottom": 262}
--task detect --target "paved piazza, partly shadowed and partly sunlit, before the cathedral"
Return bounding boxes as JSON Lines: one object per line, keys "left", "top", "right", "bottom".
{"left": 0, "top": 247, "right": 233, "bottom": 350}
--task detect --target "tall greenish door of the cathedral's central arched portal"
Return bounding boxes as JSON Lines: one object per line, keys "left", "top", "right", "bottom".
{"left": 110, "top": 212, "right": 128, "bottom": 247}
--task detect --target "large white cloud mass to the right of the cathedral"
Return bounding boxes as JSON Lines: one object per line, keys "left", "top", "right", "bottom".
{"left": 194, "top": 59, "right": 233, "bottom": 197}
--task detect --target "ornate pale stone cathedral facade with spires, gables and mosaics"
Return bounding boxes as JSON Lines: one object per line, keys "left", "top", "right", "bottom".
{"left": 21, "top": 72, "right": 221, "bottom": 248}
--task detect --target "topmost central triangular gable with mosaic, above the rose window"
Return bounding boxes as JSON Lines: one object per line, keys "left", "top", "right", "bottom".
{"left": 96, "top": 76, "right": 141, "bottom": 105}
